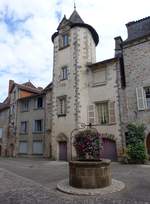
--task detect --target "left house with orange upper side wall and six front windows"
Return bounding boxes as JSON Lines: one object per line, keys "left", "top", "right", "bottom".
{"left": 4, "top": 80, "right": 50, "bottom": 157}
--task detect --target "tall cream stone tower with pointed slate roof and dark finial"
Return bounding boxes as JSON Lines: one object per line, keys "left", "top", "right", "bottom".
{"left": 52, "top": 9, "right": 99, "bottom": 160}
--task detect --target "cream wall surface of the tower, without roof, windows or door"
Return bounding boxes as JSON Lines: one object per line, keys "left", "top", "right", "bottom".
{"left": 52, "top": 27, "right": 95, "bottom": 159}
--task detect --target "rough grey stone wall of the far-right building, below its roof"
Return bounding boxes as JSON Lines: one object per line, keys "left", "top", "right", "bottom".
{"left": 120, "top": 37, "right": 150, "bottom": 136}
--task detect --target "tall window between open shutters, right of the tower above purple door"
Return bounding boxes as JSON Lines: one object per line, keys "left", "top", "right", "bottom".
{"left": 97, "top": 102, "right": 109, "bottom": 125}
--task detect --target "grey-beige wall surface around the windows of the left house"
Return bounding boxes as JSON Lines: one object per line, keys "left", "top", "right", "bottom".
{"left": 16, "top": 95, "right": 46, "bottom": 155}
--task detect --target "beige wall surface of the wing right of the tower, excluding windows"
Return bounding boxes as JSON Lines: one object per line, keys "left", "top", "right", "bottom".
{"left": 88, "top": 62, "right": 122, "bottom": 156}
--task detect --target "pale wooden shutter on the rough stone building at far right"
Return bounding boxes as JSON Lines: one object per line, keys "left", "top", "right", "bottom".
{"left": 136, "top": 87, "right": 147, "bottom": 110}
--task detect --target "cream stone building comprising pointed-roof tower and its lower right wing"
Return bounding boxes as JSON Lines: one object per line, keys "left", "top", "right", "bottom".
{"left": 52, "top": 10, "right": 122, "bottom": 160}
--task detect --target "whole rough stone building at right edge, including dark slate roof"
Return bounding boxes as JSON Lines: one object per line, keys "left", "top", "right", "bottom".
{"left": 116, "top": 17, "right": 150, "bottom": 154}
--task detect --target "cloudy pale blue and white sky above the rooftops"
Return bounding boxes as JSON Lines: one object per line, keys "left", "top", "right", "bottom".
{"left": 0, "top": 0, "right": 150, "bottom": 102}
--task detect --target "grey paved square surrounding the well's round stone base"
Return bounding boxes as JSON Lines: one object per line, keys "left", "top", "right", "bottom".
{"left": 0, "top": 159, "right": 150, "bottom": 204}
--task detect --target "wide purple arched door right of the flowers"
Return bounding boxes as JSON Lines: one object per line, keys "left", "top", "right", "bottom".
{"left": 101, "top": 138, "right": 117, "bottom": 161}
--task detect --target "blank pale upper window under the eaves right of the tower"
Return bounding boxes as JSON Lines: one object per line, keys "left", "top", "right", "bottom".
{"left": 93, "top": 68, "right": 106, "bottom": 86}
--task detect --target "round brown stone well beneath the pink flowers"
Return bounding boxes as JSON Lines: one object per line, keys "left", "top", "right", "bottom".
{"left": 69, "top": 159, "right": 112, "bottom": 189}
